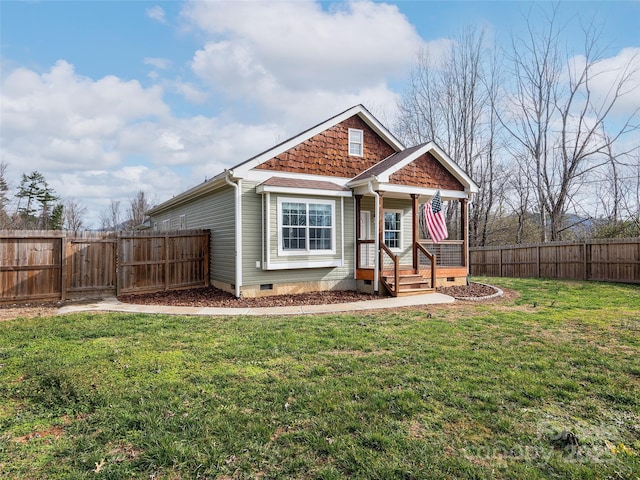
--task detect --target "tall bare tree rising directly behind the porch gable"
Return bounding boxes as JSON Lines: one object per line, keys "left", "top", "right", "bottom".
{"left": 397, "top": 28, "right": 499, "bottom": 245}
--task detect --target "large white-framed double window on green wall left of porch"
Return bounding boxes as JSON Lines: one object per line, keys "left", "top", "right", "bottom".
{"left": 278, "top": 198, "right": 336, "bottom": 255}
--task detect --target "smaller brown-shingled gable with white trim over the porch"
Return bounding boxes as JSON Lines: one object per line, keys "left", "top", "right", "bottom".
{"left": 348, "top": 142, "right": 478, "bottom": 193}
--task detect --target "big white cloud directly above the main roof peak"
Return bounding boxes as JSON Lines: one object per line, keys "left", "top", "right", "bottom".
{"left": 183, "top": 1, "right": 438, "bottom": 127}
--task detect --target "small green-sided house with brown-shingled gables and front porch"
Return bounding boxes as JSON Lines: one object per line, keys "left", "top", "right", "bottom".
{"left": 147, "top": 105, "right": 478, "bottom": 297}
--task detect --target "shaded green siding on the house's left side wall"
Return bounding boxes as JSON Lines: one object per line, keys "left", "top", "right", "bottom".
{"left": 151, "top": 185, "right": 235, "bottom": 284}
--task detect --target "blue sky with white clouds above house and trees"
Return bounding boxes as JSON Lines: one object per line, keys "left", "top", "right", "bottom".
{"left": 0, "top": 0, "right": 640, "bottom": 228}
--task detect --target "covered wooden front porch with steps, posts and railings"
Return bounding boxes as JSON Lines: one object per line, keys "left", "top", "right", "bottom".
{"left": 355, "top": 189, "right": 469, "bottom": 296}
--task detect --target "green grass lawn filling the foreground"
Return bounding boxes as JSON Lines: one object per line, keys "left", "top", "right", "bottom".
{"left": 0, "top": 279, "right": 640, "bottom": 480}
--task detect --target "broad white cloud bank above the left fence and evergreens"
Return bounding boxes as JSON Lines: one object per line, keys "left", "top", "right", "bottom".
{"left": 0, "top": 61, "right": 177, "bottom": 227}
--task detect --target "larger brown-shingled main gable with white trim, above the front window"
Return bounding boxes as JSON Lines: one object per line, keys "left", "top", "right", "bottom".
{"left": 231, "top": 105, "right": 404, "bottom": 178}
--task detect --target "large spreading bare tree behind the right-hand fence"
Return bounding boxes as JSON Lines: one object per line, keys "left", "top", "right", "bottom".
{"left": 501, "top": 5, "right": 638, "bottom": 241}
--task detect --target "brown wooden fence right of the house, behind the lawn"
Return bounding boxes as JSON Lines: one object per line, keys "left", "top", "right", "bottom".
{"left": 469, "top": 238, "right": 640, "bottom": 283}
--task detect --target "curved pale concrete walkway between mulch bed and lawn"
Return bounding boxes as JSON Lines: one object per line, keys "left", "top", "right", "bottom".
{"left": 58, "top": 293, "right": 455, "bottom": 316}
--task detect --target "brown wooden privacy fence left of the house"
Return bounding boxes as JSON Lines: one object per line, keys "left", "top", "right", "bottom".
{"left": 0, "top": 230, "right": 210, "bottom": 304}
